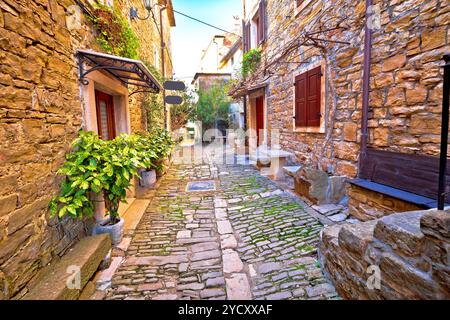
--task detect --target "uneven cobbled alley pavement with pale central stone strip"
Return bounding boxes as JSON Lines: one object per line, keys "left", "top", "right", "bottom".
{"left": 101, "top": 147, "right": 338, "bottom": 300}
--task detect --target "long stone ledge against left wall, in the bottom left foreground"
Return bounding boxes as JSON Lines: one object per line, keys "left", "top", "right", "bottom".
{"left": 23, "top": 234, "right": 111, "bottom": 300}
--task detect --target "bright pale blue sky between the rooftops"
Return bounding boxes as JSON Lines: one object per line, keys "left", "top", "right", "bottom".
{"left": 171, "top": 0, "right": 242, "bottom": 83}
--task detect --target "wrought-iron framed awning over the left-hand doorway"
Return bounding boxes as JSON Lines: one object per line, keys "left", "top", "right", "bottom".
{"left": 77, "top": 50, "right": 162, "bottom": 96}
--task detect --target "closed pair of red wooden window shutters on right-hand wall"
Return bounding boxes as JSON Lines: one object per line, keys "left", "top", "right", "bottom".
{"left": 294, "top": 66, "right": 322, "bottom": 128}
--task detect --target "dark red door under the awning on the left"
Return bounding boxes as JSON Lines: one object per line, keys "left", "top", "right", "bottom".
{"left": 95, "top": 90, "right": 116, "bottom": 140}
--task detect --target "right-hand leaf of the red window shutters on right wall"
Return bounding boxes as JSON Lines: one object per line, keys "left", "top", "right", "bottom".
{"left": 306, "top": 67, "right": 322, "bottom": 127}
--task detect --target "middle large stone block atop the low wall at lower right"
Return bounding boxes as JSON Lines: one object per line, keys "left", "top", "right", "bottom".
{"left": 374, "top": 211, "right": 425, "bottom": 256}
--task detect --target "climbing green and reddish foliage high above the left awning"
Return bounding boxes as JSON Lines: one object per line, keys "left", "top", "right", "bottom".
{"left": 89, "top": 3, "right": 139, "bottom": 59}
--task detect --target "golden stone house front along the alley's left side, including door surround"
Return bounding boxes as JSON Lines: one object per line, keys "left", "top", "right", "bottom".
{"left": 0, "top": 0, "right": 174, "bottom": 299}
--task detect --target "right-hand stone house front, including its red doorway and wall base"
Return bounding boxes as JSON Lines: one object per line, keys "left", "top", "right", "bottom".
{"left": 236, "top": 0, "right": 450, "bottom": 220}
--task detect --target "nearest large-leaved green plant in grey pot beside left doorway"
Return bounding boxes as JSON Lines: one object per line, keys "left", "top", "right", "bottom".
{"left": 50, "top": 131, "right": 141, "bottom": 245}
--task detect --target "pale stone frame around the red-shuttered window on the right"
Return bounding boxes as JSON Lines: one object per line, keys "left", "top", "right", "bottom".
{"left": 292, "top": 60, "right": 328, "bottom": 133}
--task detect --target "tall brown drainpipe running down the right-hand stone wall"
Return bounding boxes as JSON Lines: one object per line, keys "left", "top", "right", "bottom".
{"left": 359, "top": 0, "right": 372, "bottom": 174}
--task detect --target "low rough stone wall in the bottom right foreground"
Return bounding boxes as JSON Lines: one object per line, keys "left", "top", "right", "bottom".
{"left": 320, "top": 211, "right": 450, "bottom": 300}
